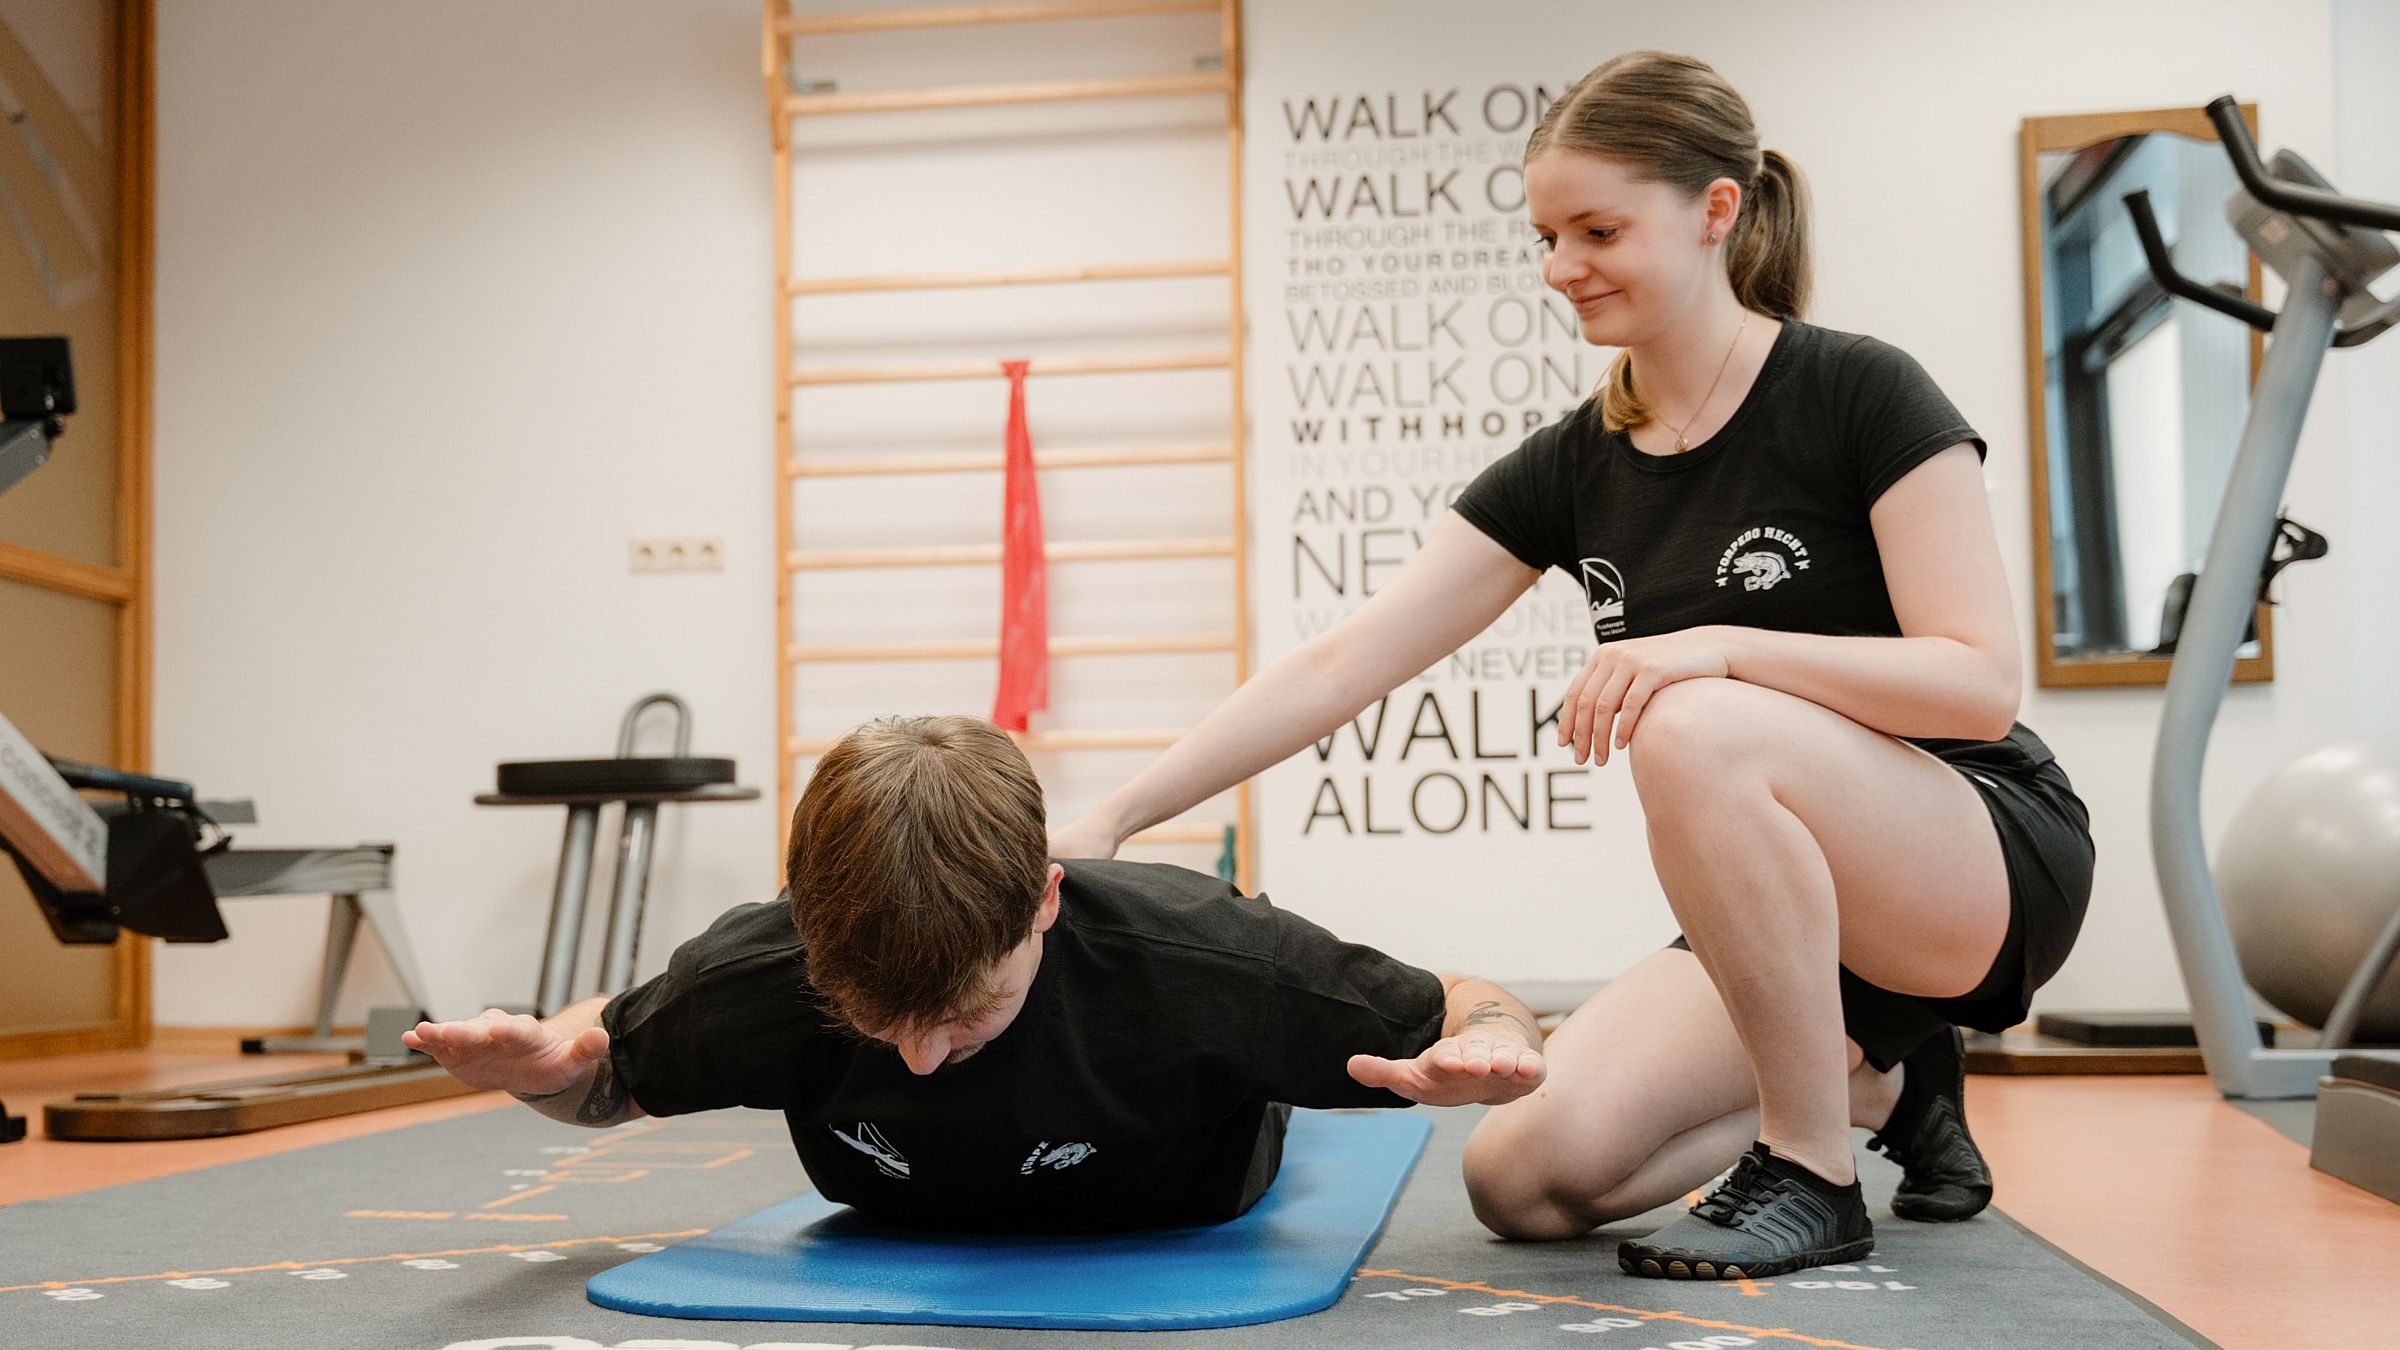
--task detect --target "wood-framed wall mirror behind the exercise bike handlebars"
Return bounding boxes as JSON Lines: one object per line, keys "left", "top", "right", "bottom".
{"left": 2021, "top": 103, "right": 2275, "bottom": 687}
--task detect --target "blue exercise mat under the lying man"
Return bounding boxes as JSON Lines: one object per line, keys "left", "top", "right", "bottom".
{"left": 583, "top": 1110, "right": 1433, "bottom": 1331}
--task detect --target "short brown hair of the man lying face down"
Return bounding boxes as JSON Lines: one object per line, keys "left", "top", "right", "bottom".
{"left": 785, "top": 716, "right": 1049, "bottom": 1031}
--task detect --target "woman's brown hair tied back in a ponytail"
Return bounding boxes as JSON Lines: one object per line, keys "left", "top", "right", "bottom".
{"left": 1524, "top": 50, "right": 1812, "bottom": 432}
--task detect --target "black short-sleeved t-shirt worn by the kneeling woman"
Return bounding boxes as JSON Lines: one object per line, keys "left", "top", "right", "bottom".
{"left": 1457, "top": 309, "right": 2050, "bottom": 761}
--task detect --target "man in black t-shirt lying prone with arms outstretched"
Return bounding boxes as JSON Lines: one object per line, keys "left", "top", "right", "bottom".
{"left": 403, "top": 716, "right": 1543, "bottom": 1232}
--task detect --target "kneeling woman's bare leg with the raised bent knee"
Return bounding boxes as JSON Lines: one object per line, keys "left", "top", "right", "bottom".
{"left": 1632, "top": 680, "right": 2009, "bottom": 1182}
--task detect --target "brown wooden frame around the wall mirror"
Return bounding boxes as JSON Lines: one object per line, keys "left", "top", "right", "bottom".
{"left": 2018, "top": 103, "right": 2275, "bottom": 689}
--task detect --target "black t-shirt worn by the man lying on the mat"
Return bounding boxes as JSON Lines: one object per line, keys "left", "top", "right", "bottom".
{"left": 600, "top": 860, "right": 1445, "bottom": 1232}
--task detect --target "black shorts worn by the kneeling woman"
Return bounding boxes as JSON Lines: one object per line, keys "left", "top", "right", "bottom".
{"left": 1670, "top": 725, "right": 2093, "bottom": 1069}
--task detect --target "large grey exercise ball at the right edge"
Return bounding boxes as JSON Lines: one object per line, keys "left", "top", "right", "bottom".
{"left": 2218, "top": 740, "right": 2400, "bottom": 1045}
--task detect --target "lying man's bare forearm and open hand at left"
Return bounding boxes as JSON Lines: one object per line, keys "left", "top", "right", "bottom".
{"left": 401, "top": 997, "right": 646, "bottom": 1129}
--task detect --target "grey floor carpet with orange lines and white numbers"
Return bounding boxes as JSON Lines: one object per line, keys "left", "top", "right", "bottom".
{"left": 0, "top": 1110, "right": 2206, "bottom": 1350}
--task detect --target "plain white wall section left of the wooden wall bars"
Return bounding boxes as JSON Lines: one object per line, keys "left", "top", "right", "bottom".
{"left": 156, "top": 0, "right": 778, "bottom": 1026}
